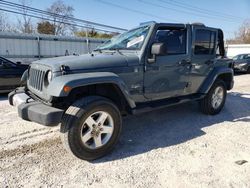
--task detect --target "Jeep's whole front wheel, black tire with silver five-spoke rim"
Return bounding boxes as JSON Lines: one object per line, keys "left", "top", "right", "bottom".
{"left": 61, "top": 96, "right": 122, "bottom": 161}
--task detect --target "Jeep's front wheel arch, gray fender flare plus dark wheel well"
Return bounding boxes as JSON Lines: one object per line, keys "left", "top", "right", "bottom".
{"left": 49, "top": 72, "right": 135, "bottom": 110}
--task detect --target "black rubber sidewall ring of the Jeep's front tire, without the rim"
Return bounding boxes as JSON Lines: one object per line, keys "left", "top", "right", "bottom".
{"left": 68, "top": 100, "right": 122, "bottom": 160}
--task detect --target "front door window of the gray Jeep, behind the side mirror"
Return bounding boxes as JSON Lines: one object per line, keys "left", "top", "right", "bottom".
{"left": 155, "top": 28, "right": 187, "bottom": 55}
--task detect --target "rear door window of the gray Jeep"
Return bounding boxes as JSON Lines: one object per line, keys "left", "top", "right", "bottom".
{"left": 194, "top": 29, "right": 216, "bottom": 55}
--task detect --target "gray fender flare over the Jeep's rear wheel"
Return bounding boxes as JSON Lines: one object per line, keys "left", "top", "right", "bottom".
{"left": 198, "top": 67, "right": 234, "bottom": 94}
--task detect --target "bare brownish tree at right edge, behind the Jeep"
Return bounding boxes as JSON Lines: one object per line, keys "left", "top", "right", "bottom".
{"left": 227, "top": 19, "right": 250, "bottom": 44}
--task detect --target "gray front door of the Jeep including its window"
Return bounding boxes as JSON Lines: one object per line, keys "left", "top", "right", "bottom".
{"left": 144, "top": 26, "right": 191, "bottom": 100}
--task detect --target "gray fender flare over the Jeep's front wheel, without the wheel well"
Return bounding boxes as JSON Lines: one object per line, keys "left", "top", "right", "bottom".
{"left": 47, "top": 72, "right": 135, "bottom": 108}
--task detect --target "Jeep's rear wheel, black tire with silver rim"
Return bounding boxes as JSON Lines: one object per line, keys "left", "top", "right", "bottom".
{"left": 200, "top": 80, "right": 227, "bottom": 115}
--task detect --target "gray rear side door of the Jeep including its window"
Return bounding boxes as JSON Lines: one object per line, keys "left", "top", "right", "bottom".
{"left": 189, "top": 26, "right": 218, "bottom": 94}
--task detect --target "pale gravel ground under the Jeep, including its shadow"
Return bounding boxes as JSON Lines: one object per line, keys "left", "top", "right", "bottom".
{"left": 0, "top": 75, "right": 250, "bottom": 188}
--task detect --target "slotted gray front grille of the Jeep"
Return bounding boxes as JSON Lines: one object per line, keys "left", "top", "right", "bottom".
{"left": 29, "top": 67, "right": 46, "bottom": 91}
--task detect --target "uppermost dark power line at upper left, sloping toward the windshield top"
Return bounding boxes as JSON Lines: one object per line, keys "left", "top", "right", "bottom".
{"left": 0, "top": 0, "right": 126, "bottom": 31}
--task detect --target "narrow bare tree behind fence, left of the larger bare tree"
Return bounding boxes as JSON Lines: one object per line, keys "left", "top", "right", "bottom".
{"left": 17, "top": 0, "right": 34, "bottom": 33}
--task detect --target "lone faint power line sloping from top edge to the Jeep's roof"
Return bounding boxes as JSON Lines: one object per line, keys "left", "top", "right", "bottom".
{"left": 95, "top": 0, "right": 179, "bottom": 22}
